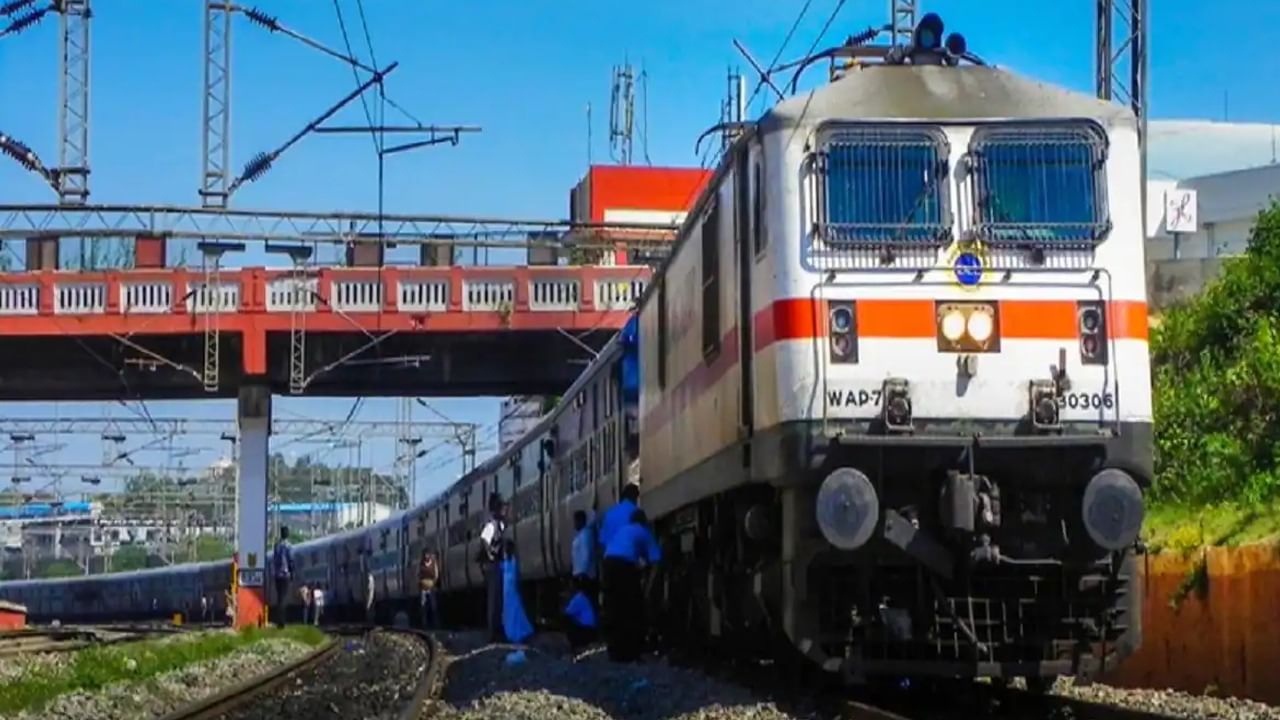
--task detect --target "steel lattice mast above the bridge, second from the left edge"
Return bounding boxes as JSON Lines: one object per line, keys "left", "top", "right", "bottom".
{"left": 200, "top": 0, "right": 234, "bottom": 208}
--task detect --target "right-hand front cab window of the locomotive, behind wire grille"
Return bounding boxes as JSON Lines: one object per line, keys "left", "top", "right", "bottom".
{"left": 969, "top": 122, "right": 1110, "bottom": 246}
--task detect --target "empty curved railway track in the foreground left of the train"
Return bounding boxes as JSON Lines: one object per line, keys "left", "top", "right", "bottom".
{"left": 163, "top": 626, "right": 442, "bottom": 720}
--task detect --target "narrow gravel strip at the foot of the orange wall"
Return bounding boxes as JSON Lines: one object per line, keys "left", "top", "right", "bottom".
{"left": 1052, "top": 678, "right": 1280, "bottom": 720}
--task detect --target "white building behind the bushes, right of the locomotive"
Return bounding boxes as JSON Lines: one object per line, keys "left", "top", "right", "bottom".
{"left": 1147, "top": 120, "right": 1280, "bottom": 307}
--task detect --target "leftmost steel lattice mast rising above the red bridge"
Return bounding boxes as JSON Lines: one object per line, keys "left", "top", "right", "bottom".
{"left": 56, "top": 0, "right": 90, "bottom": 204}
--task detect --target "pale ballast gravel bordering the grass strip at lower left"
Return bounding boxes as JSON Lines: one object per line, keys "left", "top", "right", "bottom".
{"left": 5, "top": 639, "right": 311, "bottom": 720}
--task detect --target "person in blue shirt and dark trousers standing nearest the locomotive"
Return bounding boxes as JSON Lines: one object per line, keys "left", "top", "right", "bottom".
{"left": 604, "top": 510, "right": 662, "bottom": 662}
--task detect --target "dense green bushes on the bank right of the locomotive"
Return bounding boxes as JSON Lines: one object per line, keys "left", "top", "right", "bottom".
{"left": 1152, "top": 204, "right": 1280, "bottom": 505}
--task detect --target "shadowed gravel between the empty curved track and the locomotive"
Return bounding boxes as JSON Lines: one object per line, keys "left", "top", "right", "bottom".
{"left": 434, "top": 633, "right": 808, "bottom": 720}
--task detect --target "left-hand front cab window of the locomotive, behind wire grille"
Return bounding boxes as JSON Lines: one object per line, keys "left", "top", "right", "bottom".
{"left": 815, "top": 127, "right": 951, "bottom": 246}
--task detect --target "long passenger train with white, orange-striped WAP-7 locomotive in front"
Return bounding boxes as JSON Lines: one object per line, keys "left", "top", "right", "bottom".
{"left": 0, "top": 14, "right": 1153, "bottom": 687}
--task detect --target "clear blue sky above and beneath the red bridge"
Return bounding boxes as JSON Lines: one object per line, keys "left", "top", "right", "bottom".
{"left": 0, "top": 0, "right": 1280, "bottom": 504}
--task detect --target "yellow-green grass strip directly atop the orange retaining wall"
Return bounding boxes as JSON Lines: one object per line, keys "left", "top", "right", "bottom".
{"left": 1143, "top": 502, "right": 1280, "bottom": 553}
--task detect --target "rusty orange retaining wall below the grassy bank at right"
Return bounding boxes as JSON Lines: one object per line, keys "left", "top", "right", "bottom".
{"left": 1103, "top": 544, "right": 1280, "bottom": 705}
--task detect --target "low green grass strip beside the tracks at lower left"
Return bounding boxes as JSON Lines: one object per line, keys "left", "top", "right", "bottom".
{"left": 0, "top": 625, "right": 325, "bottom": 715}
